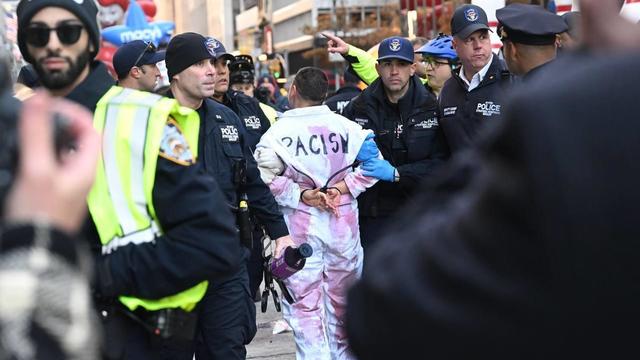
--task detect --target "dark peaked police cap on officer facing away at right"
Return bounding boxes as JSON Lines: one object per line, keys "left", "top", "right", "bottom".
{"left": 496, "top": 4, "right": 567, "bottom": 45}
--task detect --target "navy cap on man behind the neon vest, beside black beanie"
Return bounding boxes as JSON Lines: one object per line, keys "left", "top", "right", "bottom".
{"left": 113, "top": 40, "right": 165, "bottom": 79}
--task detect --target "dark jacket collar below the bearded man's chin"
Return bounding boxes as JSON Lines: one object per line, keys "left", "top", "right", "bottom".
{"left": 66, "top": 61, "right": 116, "bottom": 113}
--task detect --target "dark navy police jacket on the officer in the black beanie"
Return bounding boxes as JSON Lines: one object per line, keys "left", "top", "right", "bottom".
{"left": 192, "top": 99, "right": 289, "bottom": 239}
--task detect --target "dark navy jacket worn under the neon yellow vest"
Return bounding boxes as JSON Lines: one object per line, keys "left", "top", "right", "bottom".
{"left": 67, "top": 66, "right": 241, "bottom": 299}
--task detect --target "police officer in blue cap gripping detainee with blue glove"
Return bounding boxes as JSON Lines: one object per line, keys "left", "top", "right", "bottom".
{"left": 343, "top": 36, "right": 448, "bottom": 252}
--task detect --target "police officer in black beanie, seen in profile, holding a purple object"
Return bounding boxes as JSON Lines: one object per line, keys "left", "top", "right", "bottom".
{"left": 166, "top": 33, "right": 293, "bottom": 360}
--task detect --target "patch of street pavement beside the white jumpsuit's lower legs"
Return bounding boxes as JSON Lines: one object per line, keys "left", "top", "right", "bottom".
{"left": 247, "top": 298, "right": 296, "bottom": 360}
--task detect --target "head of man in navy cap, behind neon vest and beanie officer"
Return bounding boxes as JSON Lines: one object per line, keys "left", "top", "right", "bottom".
{"left": 113, "top": 40, "right": 164, "bottom": 92}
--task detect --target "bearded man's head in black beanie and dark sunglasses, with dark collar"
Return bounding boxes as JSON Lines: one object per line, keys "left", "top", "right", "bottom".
{"left": 17, "top": 0, "right": 114, "bottom": 112}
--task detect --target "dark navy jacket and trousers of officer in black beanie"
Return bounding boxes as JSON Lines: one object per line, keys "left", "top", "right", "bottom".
{"left": 196, "top": 99, "right": 289, "bottom": 360}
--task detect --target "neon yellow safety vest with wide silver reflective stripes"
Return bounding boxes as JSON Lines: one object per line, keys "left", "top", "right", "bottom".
{"left": 87, "top": 86, "right": 207, "bottom": 311}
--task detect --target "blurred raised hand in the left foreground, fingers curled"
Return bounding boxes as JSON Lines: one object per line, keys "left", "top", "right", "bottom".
{"left": 4, "top": 93, "right": 100, "bottom": 233}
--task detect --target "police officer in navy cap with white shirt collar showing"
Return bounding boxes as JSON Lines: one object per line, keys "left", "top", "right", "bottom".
{"left": 440, "top": 5, "right": 511, "bottom": 153}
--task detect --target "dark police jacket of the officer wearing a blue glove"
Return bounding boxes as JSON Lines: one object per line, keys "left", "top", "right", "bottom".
{"left": 343, "top": 76, "right": 448, "bottom": 217}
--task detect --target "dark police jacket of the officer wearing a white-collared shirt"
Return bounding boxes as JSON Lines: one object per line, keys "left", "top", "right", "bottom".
{"left": 440, "top": 55, "right": 511, "bottom": 153}
